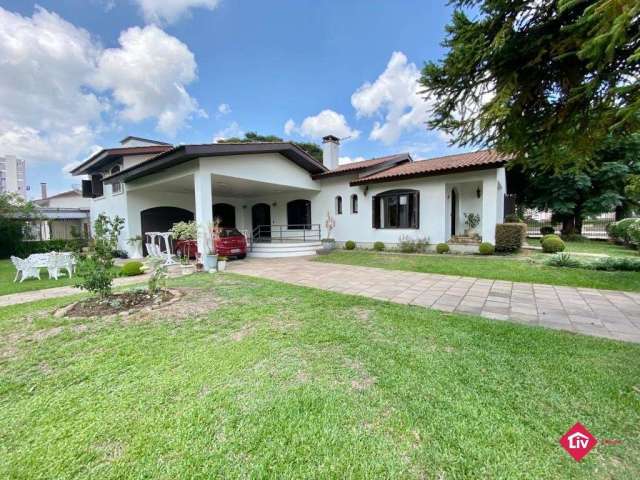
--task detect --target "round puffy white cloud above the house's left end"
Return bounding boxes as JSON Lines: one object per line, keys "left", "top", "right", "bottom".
{"left": 93, "top": 25, "right": 205, "bottom": 135}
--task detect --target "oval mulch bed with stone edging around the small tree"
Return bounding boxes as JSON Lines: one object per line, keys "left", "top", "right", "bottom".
{"left": 61, "top": 290, "right": 176, "bottom": 318}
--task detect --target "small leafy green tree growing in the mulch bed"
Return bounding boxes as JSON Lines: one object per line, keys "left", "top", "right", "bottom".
{"left": 76, "top": 213, "right": 124, "bottom": 299}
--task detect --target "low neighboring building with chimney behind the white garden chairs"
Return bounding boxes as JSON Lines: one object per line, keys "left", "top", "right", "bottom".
{"left": 31, "top": 183, "right": 91, "bottom": 240}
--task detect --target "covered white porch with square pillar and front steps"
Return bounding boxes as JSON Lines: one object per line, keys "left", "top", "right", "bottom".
{"left": 127, "top": 163, "right": 321, "bottom": 257}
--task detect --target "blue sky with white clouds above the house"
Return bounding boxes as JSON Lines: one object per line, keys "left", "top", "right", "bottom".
{"left": 0, "top": 0, "right": 464, "bottom": 194}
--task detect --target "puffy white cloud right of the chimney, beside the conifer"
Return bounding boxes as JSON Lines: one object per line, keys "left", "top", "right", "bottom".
{"left": 351, "top": 52, "right": 430, "bottom": 144}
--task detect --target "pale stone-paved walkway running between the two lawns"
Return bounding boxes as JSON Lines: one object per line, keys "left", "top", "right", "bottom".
{"left": 227, "top": 257, "right": 640, "bottom": 343}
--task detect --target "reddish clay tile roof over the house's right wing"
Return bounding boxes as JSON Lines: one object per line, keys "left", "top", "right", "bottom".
{"left": 351, "top": 150, "right": 511, "bottom": 185}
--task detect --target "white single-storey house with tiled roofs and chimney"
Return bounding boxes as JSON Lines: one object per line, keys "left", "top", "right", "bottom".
{"left": 73, "top": 136, "right": 506, "bottom": 255}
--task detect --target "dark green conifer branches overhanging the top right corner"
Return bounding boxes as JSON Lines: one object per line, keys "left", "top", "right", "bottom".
{"left": 420, "top": 0, "right": 640, "bottom": 172}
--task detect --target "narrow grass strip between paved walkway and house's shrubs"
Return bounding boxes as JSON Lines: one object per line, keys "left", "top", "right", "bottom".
{"left": 314, "top": 250, "right": 640, "bottom": 291}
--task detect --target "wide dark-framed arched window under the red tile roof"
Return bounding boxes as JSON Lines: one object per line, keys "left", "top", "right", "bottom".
{"left": 372, "top": 190, "right": 420, "bottom": 228}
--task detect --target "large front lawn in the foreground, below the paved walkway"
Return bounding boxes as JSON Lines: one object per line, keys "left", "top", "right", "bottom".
{"left": 0, "top": 274, "right": 640, "bottom": 479}
